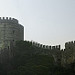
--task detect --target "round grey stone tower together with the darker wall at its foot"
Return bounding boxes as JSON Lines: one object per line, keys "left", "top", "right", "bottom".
{"left": 0, "top": 17, "right": 24, "bottom": 63}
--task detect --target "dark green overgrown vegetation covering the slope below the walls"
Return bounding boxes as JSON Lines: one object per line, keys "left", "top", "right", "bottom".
{"left": 0, "top": 41, "right": 75, "bottom": 75}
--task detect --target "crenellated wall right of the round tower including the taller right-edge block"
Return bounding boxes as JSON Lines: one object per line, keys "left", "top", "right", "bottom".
{"left": 29, "top": 41, "right": 75, "bottom": 65}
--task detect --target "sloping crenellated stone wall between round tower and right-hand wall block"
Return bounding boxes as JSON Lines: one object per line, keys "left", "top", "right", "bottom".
{"left": 28, "top": 41, "right": 61, "bottom": 64}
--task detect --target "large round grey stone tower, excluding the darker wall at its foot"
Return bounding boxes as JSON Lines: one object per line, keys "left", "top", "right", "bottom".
{"left": 0, "top": 17, "right": 24, "bottom": 49}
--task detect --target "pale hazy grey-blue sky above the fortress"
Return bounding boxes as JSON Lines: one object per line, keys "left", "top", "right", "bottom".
{"left": 0, "top": 0, "right": 75, "bottom": 47}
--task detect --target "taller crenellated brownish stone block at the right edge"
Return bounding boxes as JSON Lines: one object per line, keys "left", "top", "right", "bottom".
{"left": 61, "top": 41, "right": 75, "bottom": 65}
